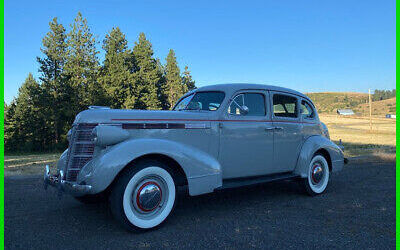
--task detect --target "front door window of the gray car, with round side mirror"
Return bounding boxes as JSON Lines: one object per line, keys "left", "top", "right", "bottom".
{"left": 228, "top": 93, "right": 266, "bottom": 116}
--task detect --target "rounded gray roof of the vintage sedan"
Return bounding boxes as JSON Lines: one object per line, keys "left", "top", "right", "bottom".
{"left": 194, "top": 83, "right": 311, "bottom": 101}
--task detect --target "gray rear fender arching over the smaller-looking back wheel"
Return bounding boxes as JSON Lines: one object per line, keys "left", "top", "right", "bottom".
{"left": 294, "top": 135, "right": 344, "bottom": 178}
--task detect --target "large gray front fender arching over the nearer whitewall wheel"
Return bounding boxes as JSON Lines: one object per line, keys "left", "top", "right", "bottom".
{"left": 78, "top": 139, "right": 222, "bottom": 195}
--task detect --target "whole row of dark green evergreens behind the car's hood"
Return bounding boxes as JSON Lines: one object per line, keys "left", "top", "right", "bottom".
{"left": 4, "top": 13, "right": 196, "bottom": 152}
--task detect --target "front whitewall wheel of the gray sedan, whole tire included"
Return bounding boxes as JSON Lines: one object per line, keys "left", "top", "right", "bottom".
{"left": 110, "top": 160, "right": 176, "bottom": 231}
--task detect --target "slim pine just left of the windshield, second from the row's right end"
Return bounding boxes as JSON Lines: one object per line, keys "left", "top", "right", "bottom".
{"left": 163, "top": 49, "right": 188, "bottom": 109}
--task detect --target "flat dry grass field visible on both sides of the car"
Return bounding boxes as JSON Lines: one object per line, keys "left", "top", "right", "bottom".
{"left": 4, "top": 114, "right": 396, "bottom": 175}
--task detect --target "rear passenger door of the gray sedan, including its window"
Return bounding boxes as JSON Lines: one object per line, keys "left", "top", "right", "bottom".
{"left": 270, "top": 91, "right": 303, "bottom": 173}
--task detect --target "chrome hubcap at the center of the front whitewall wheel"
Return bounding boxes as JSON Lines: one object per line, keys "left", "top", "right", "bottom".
{"left": 136, "top": 181, "right": 162, "bottom": 212}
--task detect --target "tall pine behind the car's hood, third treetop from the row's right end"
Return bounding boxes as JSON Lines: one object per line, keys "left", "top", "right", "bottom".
{"left": 130, "top": 33, "right": 162, "bottom": 109}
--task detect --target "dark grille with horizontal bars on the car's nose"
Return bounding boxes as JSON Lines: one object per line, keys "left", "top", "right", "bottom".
{"left": 66, "top": 123, "right": 97, "bottom": 181}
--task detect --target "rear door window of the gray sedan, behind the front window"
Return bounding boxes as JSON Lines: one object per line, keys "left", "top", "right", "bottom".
{"left": 273, "top": 94, "right": 297, "bottom": 118}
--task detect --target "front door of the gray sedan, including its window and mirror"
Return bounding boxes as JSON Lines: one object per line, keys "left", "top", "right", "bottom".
{"left": 218, "top": 90, "right": 273, "bottom": 179}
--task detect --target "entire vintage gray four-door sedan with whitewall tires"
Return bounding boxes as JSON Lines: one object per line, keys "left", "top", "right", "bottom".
{"left": 44, "top": 84, "right": 345, "bottom": 230}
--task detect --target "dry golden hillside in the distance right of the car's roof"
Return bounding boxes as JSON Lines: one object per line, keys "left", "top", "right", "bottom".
{"left": 306, "top": 92, "right": 396, "bottom": 116}
